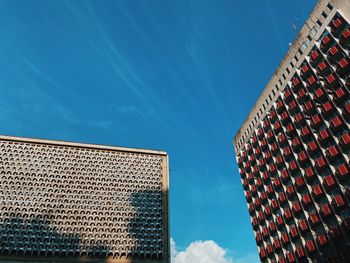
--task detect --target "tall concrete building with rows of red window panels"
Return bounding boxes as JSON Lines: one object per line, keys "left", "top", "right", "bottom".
{"left": 234, "top": 0, "right": 350, "bottom": 262}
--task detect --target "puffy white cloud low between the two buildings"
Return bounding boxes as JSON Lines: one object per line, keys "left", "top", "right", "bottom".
{"left": 171, "top": 239, "right": 233, "bottom": 263}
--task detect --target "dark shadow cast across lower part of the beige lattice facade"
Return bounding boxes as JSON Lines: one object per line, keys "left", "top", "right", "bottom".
{"left": 0, "top": 190, "right": 169, "bottom": 263}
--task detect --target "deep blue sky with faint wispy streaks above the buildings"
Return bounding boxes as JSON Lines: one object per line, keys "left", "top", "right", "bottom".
{"left": 0, "top": 0, "right": 316, "bottom": 262}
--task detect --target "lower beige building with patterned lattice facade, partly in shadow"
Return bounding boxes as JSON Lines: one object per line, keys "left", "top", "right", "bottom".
{"left": 0, "top": 136, "right": 170, "bottom": 263}
